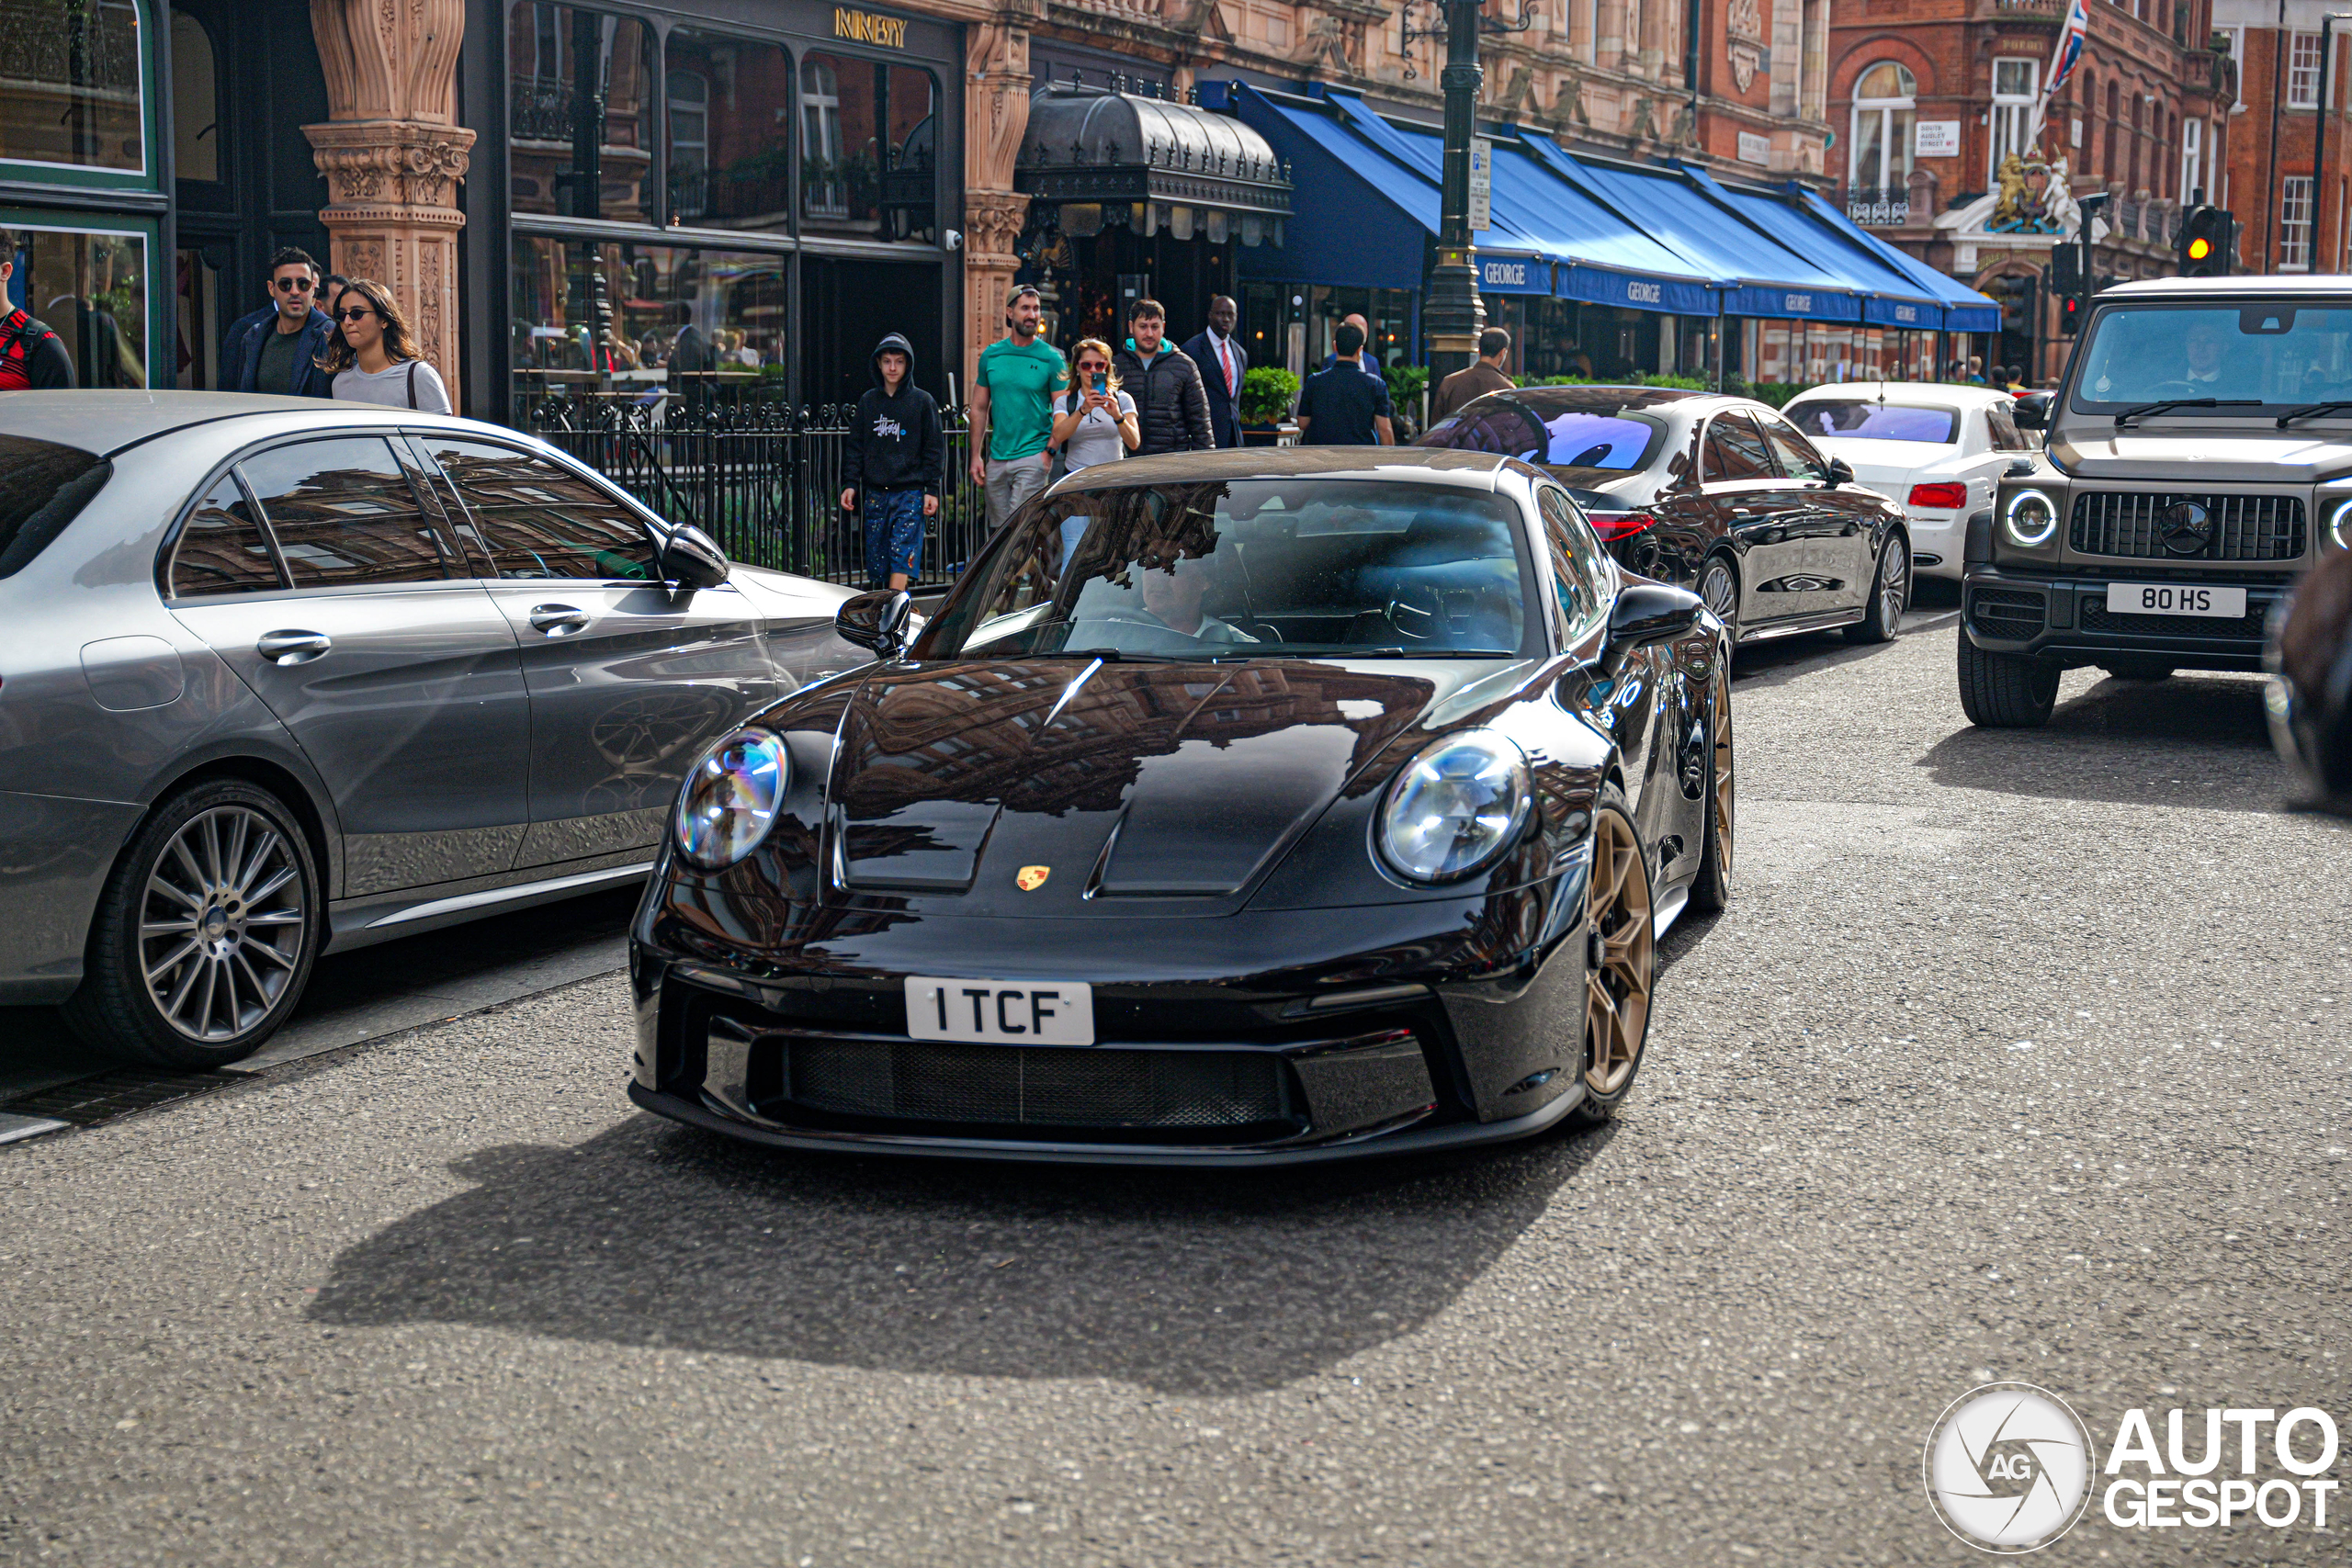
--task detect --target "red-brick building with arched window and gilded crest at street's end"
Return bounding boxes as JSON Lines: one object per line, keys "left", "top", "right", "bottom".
{"left": 1827, "top": 0, "right": 2229, "bottom": 381}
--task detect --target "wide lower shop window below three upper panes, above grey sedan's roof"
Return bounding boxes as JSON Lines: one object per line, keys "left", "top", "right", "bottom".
{"left": 508, "top": 235, "right": 790, "bottom": 416}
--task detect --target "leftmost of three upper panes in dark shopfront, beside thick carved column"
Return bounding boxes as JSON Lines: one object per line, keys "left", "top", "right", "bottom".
{"left": 507, "top": 0, "right": 654, "bottom": 223}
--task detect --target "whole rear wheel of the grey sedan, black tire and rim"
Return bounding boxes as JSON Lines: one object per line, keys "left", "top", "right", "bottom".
{"left": 63, "top": 778, "right": 324, "bottom": 1069}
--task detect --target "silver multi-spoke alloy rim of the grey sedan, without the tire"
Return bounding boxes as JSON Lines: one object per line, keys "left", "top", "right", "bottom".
{"left": 139, "top": 807, "right": 308, "bottom": 1046}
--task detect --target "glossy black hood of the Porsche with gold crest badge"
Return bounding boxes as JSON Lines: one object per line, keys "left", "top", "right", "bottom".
{"left": 828, "top": 659, "right": 1494, "bottom": 917}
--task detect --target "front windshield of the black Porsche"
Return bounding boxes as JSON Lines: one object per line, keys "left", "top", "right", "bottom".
{"left": 915, "top": 478, "right": 1536, "bottom": 659}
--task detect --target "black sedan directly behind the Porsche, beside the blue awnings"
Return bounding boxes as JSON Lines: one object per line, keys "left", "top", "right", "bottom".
{"left": 1414, "top": 386, "right": 1912, "bottom": 642}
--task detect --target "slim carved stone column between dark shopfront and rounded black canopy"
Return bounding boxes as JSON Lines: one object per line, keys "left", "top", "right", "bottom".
{"left": 957, "top": 9, "right": 1030, "bottom": 400}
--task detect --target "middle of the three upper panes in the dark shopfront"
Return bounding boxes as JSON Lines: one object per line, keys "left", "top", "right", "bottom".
{"left": 668, "top": 33, "right": 793, "bottom": 231}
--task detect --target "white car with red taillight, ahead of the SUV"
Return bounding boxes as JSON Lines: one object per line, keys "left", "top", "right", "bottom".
{"left": 1782, "top": 381, "right": 2037, "bottom": 583}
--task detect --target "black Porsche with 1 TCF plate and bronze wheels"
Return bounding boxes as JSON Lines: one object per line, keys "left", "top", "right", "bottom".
{"left": 630, "top": 446, "right": 1734, "bottom": 1164}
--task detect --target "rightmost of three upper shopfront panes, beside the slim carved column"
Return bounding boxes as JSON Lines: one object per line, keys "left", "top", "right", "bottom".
{"left": 799, "top": 54, "right": 938, "bottom": 243}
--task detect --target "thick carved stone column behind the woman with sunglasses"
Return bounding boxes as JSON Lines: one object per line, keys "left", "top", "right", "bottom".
{"left": 303, "top": 0, "right": 473, "bottom": 412}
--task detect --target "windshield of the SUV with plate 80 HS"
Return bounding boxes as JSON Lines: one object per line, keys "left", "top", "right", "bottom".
{"left": 2072, "top": 301, "right": 2352, "bottom": 419}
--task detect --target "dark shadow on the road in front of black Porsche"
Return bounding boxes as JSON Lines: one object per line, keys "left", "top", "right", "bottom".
{"left": 311, "top": 1117, "right": 1613, "bottom": 1394}
